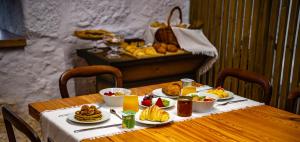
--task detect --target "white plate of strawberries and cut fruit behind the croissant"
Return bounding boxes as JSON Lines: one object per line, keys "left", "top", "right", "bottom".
{"left": 139, "top": 95, "right": 175, "bottom": 109}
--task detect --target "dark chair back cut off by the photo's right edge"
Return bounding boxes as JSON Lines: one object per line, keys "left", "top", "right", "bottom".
{"left": 286, "top": 87, "right": 300, "bottom": 114}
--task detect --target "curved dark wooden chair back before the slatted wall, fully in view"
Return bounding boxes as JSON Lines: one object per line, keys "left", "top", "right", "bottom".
{"left": 217, "top": 68, "right": 272, "bottom": 105}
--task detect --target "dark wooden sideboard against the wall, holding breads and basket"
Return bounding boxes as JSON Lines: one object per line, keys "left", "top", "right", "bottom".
{"left": 77, "top": 48, "right": 210, "bottom": 88}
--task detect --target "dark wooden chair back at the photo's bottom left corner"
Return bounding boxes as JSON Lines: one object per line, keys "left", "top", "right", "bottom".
{"left": 2, "top": 106, "right": 41, "bottom": 142}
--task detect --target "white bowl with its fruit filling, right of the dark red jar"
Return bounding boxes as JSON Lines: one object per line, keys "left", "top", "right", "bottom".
{"left": 189, "top": 93, "right": 217, "bottom": 112}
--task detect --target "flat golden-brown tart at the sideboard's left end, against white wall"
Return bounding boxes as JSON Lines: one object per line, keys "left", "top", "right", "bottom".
{"left": 74, "top": 29, "right": 114, "bottom": 39}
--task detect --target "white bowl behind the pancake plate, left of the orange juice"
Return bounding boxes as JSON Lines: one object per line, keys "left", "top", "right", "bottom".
{"left": 99, "top": 88, "right": 131, "bottom": 107}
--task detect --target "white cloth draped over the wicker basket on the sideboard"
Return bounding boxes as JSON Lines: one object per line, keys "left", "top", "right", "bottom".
{"left": 145, "top": 27, "right": 218, "bottom": 81}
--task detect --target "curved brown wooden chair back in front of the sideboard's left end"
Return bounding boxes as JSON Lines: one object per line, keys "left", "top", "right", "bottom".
{"left": 59, "top": 65, "right": 123, "bottom": 98}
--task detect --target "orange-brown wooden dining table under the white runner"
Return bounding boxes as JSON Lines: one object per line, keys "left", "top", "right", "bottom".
{"left": 29, "top": 83, "right": 300, "bottom": 142}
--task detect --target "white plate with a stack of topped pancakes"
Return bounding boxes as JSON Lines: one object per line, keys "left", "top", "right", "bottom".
{"left": 67, "top": 105, "right": 110, "bottom": 123}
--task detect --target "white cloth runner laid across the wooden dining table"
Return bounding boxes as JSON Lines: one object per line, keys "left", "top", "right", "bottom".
{"left": 41, "top": 95, "right": 263, "bottom": 142}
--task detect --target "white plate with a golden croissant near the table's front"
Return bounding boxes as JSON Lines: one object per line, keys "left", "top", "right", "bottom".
{"left": 135, "top": 105, "right": 173, "bottom": 125}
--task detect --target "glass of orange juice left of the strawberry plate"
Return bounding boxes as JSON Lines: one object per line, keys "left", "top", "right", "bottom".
{"left": 123, "top": 95, "right": 139, "bottom": 112}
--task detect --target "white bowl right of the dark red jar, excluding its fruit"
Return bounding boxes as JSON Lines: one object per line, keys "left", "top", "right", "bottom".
{"left": 189, "top": 93, "right": 217, "bottom": 112}
